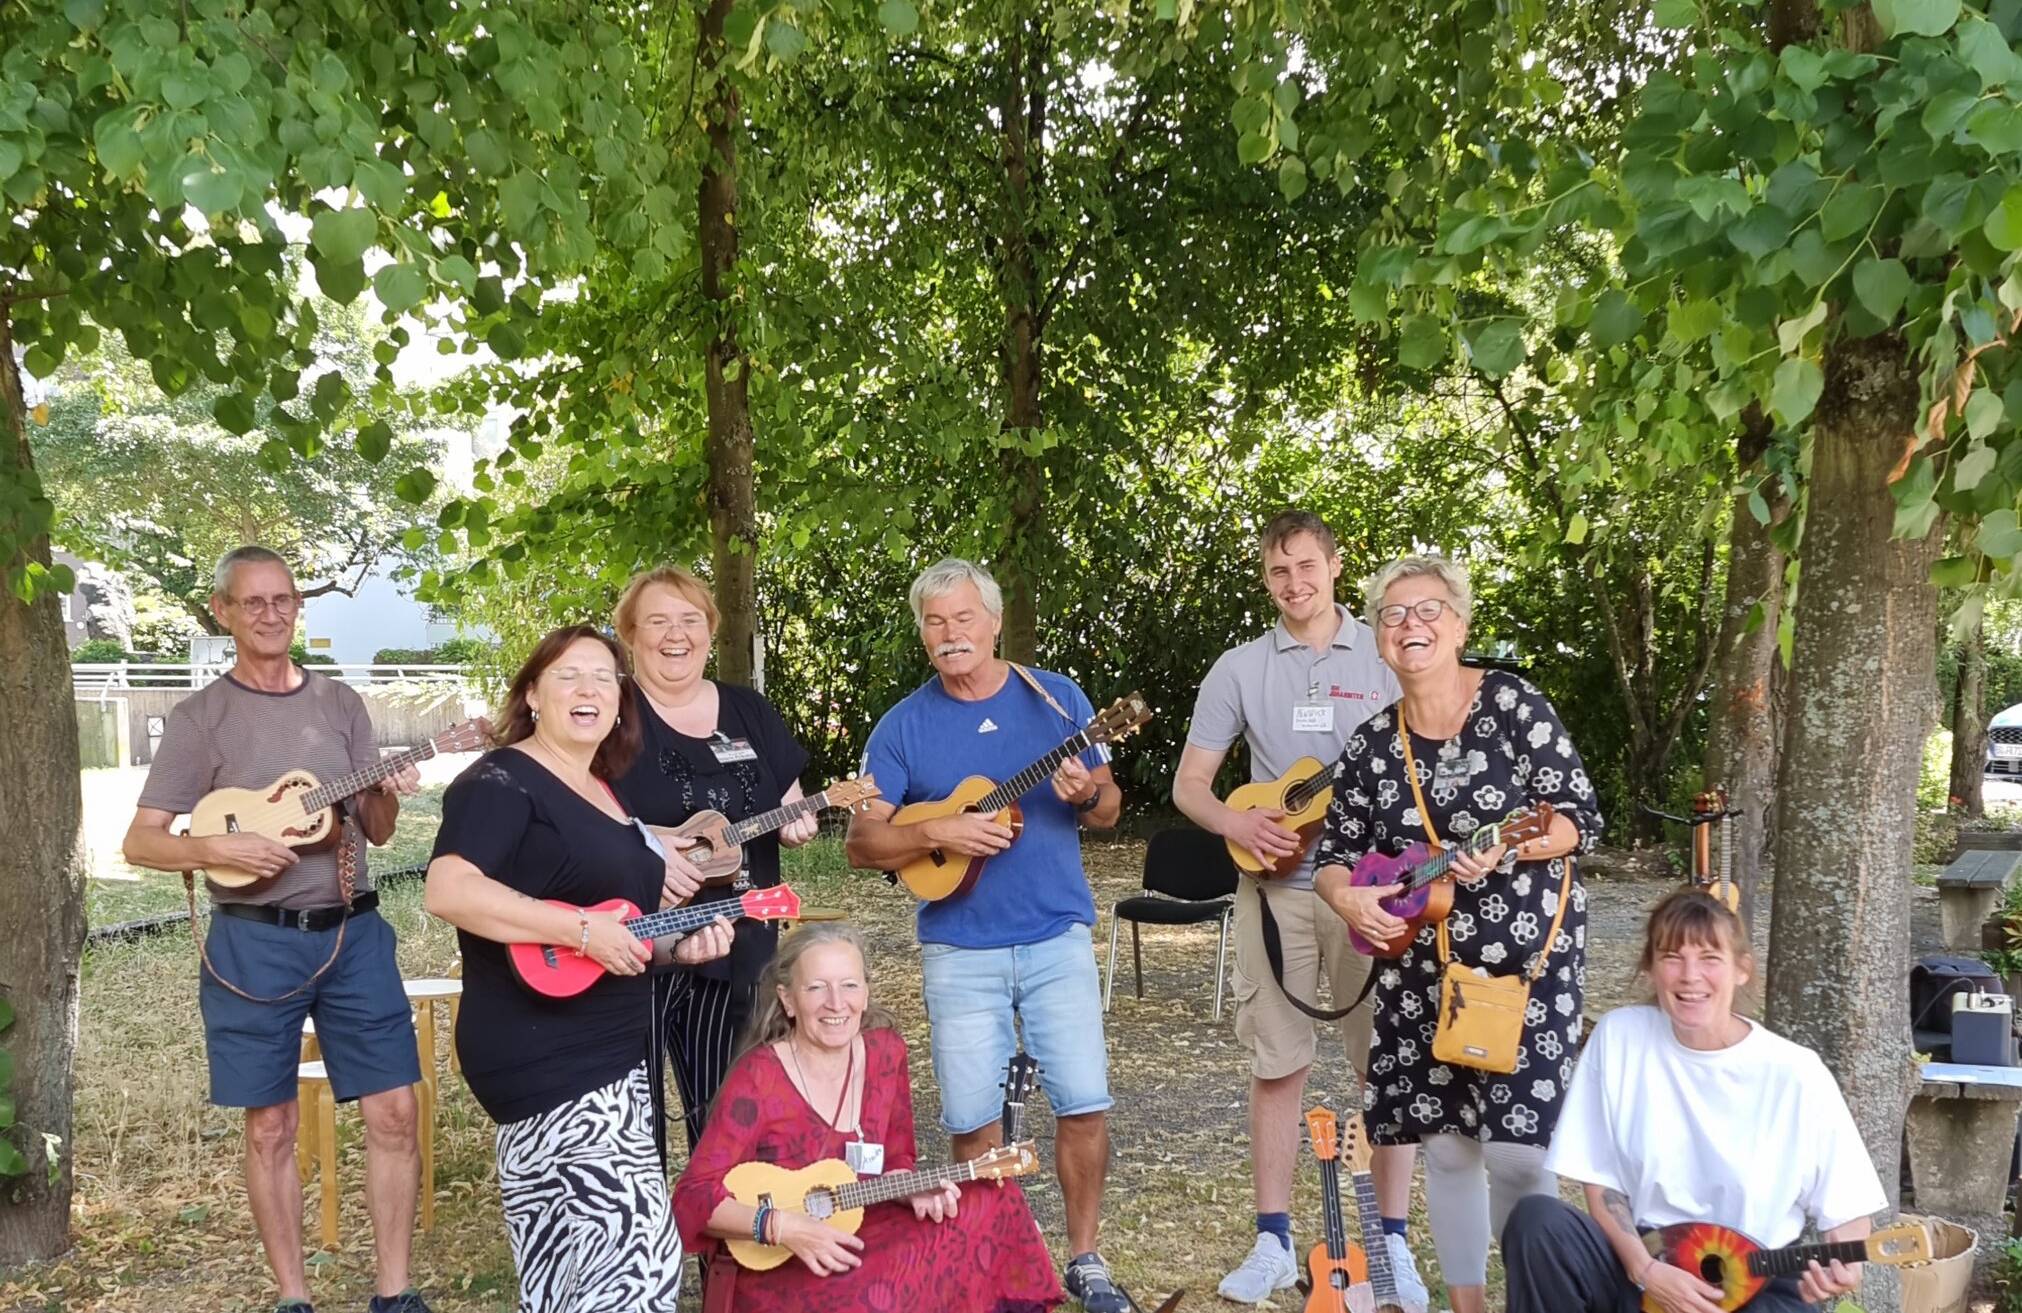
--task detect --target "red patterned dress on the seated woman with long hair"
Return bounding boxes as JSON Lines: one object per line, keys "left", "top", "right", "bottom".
{"left": 673, "top": 1030, "right": 1066, "bottom": 1313}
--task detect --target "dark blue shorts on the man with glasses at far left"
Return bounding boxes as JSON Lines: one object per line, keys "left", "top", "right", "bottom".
{"left": 196, "top": 910, "right": 421, "bottom": 1109}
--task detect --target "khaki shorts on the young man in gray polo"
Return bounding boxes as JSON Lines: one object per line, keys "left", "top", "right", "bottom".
{"left": 1235, "top": 876, "right": 1373, "bottom": 1080}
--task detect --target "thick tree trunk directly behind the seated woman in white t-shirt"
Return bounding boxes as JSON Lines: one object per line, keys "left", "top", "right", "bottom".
{"left": 1769, "top": 334, "right": 1941, "bottom": 1313}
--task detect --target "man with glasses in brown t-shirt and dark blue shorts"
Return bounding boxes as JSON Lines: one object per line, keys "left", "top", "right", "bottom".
{"left": 125, "top": 546, "right": 427, "bottom": 1313}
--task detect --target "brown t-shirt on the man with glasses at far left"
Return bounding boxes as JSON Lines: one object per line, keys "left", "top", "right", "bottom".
{"left": 140, "top": 670, "right": 380, "bottom": 908}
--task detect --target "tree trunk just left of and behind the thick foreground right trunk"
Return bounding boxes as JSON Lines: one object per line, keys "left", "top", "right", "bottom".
{"left": 1705, "top": 407, "right": 1789, "bottom": 927}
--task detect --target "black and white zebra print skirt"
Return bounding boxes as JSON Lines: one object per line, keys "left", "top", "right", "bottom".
{"left": 497, "top": 1064, "right": 681, "bottom": 1313}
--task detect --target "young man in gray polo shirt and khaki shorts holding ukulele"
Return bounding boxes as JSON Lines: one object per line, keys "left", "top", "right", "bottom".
{"left": 1173, "top": 510, "right": 1426, "bottom": 1307}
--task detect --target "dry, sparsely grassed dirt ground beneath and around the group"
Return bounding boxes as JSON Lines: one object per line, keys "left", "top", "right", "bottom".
{"left": 0, "top": 833, "right": 1937, "bottom": 1313}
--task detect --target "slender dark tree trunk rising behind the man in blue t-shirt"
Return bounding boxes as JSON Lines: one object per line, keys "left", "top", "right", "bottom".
{"left": 997, "top": 18, "right": 1045, "bottom": 662}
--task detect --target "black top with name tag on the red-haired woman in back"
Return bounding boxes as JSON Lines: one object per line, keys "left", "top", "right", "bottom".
{"left": 617, "top": 684, "right": 807, "bottom": 979}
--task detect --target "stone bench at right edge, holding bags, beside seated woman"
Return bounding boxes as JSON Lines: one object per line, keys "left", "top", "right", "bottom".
{"left": 1905, "top": 1062, "right": 2022, "bottom": 1273}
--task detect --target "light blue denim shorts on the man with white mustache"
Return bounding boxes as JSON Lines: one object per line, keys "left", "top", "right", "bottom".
{"left": 920, "top": 925, "right": 1112, "bottom": 1135}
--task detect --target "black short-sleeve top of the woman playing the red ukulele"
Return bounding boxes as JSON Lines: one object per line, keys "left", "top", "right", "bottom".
{"left": 435, "top": 749, "right": 665, "bottom": 1125}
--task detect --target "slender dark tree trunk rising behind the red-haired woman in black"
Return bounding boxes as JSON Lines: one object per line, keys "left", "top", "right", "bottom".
{"left": 696, "top": 0, "right": 758, "bottom": 684}
